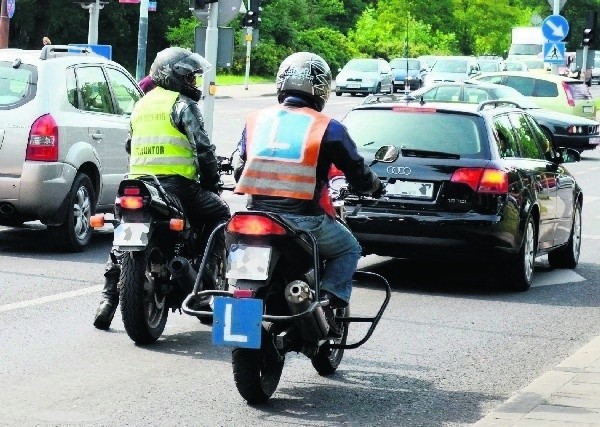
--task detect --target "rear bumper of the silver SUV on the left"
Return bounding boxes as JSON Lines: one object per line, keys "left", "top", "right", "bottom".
{"left": 0, "top": 162, "right": 77, "bottom": 225}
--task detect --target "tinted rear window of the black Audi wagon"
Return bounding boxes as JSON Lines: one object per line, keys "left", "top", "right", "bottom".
{"left": 343, "top": 108, "right": 484, "bottom": 159}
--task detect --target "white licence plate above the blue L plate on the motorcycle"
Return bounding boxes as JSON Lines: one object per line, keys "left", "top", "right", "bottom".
{"left": 225, "top": 244, "right": 271, "bottom": 280}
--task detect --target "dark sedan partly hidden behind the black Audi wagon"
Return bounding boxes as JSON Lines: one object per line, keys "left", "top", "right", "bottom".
{"left": 408, "top": 80, "right": 600, "bottom": 152}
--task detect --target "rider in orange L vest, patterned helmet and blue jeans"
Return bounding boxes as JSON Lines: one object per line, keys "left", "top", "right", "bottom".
{"left": 235, "top": 52, "right": 384, "bottom": 336}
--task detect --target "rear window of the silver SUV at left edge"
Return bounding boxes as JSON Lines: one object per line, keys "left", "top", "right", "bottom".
{"left": 0, "top": 62, "right": 37, "bottom": 110}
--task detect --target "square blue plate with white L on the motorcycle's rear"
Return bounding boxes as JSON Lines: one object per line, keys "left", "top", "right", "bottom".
{"left": 213, "top": 297, "right": 263, "bottom": 349}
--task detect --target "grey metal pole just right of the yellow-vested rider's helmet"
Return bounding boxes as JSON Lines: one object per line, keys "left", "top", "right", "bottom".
{"left": 202, "top": 2, "right": 219, "bottom": 141}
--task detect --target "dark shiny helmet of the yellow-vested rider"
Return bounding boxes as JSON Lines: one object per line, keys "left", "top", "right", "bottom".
{"left": 150, "top": 47, "right": 212, "bottom": 101}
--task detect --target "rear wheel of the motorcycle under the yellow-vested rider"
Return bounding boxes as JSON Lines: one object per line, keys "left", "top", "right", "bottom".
{"left": 119, "top": 241, "right": 169, "bottom": 344}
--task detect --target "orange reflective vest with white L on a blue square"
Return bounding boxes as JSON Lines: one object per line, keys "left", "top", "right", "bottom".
{"left": 235, "top": 106, "right": 330, "bottom": 200}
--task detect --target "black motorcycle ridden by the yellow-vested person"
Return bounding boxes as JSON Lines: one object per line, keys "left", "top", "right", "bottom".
{"left": 91, "top": 156, "right": 233, "bottom": 344}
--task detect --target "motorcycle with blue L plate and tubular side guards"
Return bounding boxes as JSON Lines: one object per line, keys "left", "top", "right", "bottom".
{"left": 182, "top": 147, "right": 391, "bottom": 404}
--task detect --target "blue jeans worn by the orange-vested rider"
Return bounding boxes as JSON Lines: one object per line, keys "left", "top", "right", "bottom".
{"left": 282, "top": 214, "right": 362, "bottom": 302}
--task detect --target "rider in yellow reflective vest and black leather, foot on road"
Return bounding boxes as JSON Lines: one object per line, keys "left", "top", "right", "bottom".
{"left": 94, "top": 47, "right": 231, "bottom": 329}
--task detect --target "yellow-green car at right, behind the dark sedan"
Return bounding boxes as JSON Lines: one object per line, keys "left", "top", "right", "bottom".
{"left": 473, "top": 71, "right": 596, "bottom": 119}
